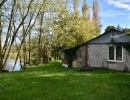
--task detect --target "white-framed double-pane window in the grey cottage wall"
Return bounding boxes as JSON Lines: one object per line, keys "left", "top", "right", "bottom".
{"left": 109, "top": 46, "right": 123, "bottom": 61}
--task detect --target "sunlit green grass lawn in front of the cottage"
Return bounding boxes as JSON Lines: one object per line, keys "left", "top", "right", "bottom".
{"left": 0, "top": 62, "right": 130, "bottom": 100}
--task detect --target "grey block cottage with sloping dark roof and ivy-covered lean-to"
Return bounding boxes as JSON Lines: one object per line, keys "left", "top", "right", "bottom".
{"left": 64, "top": 29, "right": 130, "bottom": 71}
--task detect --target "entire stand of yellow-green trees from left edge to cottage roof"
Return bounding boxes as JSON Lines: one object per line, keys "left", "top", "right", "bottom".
{"left": 0, "top": 0, "right": 99, "bottom": 70}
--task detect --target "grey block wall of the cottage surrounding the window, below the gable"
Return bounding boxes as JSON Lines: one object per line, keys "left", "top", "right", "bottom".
{"left": 88, "top": 44, "right": 130, "bottom": 71}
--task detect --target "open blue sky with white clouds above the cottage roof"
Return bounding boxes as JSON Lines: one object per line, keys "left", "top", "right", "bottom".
{"left": 82, "top": 0, "right": 130, "bottom": 33}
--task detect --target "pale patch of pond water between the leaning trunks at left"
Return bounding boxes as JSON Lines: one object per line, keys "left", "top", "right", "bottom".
{"left": 6, "top": 59, "right": 21, "bottom": 71}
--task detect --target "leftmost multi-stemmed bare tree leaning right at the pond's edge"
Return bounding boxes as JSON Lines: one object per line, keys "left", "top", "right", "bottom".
{"left": 0, "top": 0, "right": 36, "bottom": 70}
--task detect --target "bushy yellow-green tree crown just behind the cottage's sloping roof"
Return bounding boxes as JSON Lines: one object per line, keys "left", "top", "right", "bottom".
{"left": 54, "top": 15, "right": 99, "bottom": 48}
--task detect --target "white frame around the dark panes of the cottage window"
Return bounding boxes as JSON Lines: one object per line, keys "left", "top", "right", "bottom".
{"left": 107, "top": 45, "right": 124, "bottom": 62}
